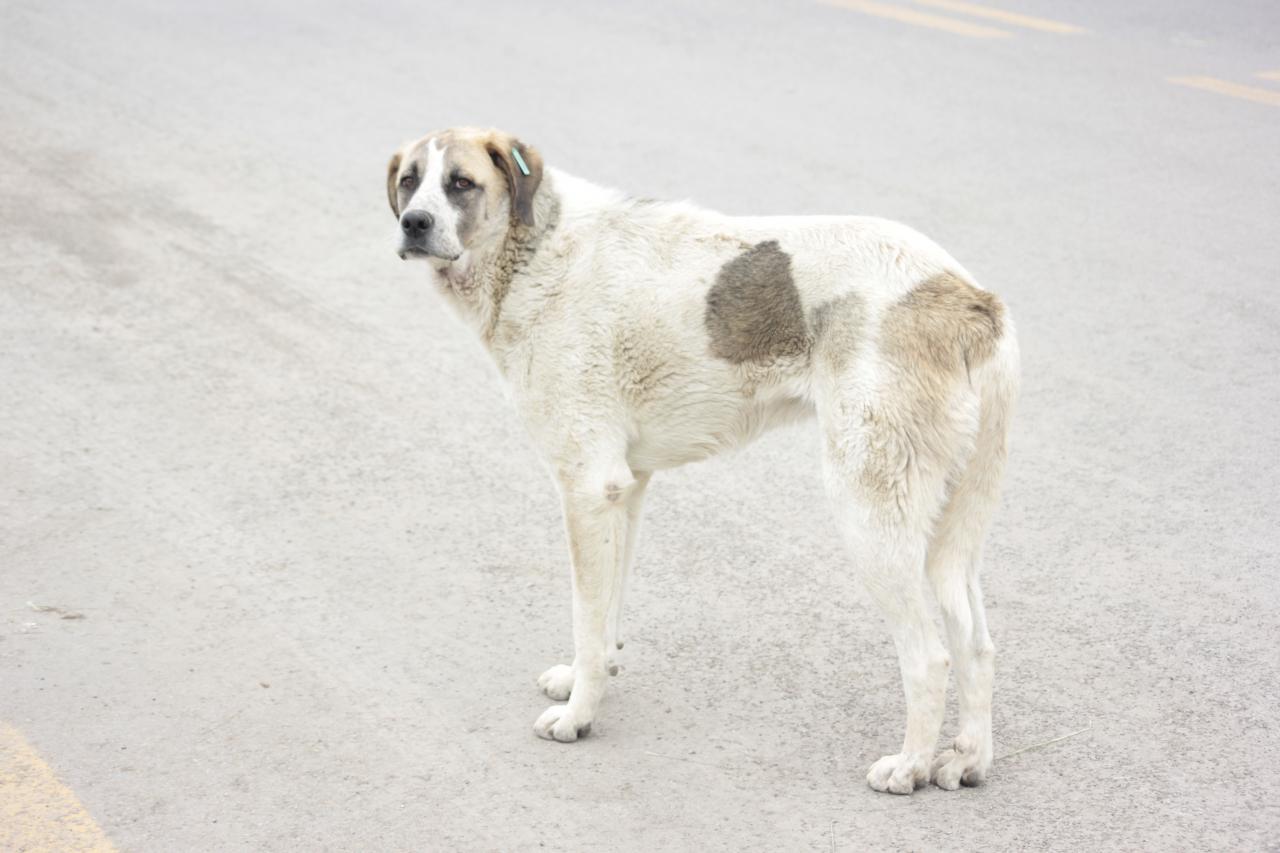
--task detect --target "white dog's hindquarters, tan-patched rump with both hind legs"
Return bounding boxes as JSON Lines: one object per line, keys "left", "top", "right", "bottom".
{"left": 814, "top": 273, "right": 1018, "bottom": 793}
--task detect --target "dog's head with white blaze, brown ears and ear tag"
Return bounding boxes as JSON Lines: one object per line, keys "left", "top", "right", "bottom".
{"left": 387, "top": 128, "right": 543, "bottom": 264}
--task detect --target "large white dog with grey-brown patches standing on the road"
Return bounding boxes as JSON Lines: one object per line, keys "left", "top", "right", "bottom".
{"left": 387, "top": 128, "right": 1019, "bottom": 794}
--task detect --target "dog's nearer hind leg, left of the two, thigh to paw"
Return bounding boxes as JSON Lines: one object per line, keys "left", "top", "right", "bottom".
{"left": 818, "top": 382, "right": 950, "bottom": 794}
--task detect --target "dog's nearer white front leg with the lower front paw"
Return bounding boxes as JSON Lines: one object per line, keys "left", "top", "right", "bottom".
{"left": 534, "top": 466, "right": 635, "bottom": 743}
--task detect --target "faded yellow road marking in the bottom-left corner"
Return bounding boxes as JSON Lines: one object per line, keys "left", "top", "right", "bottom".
{"left": 0, "top": 722, "right": 115, "bottom": 853}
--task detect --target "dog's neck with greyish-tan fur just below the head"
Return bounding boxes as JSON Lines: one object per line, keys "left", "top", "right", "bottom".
{"left": 433, "top": 179, "right": 561, "bottom": 355}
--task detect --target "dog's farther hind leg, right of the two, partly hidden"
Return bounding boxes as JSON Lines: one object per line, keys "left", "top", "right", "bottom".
{"left": 927, "top": 343, "right": 1016, "bottom": 790}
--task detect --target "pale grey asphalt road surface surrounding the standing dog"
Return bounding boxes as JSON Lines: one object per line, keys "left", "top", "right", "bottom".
{"left": 0, "top": 0, "right": 1280, "bottom": 850}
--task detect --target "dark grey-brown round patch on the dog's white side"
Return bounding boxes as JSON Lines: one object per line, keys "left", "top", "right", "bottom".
{"left": 704, "top": 240, "right": 813, "bottom": 364}
